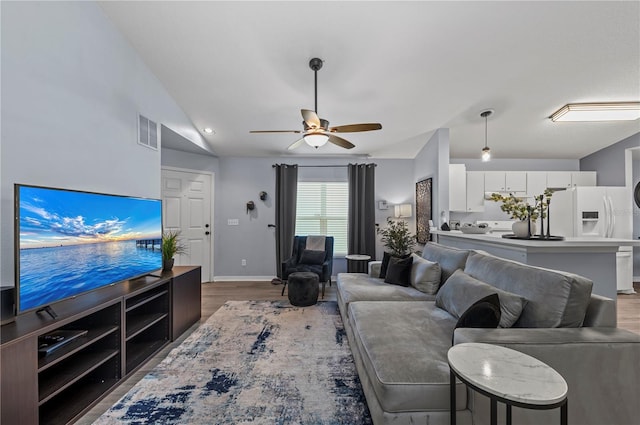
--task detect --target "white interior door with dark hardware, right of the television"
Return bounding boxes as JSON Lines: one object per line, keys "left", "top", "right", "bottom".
{"left": 162, "top": 168, "right": 213, "bottom": 282}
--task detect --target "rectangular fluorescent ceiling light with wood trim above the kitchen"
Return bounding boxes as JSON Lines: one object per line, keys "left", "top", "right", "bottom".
{"left": 549, "top": 102, "right": 640, "bottom": 121}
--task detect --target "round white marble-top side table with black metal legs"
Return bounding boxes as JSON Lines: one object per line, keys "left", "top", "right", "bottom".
{"left": 447, "top": 343, "right": 568, "bottom": 425}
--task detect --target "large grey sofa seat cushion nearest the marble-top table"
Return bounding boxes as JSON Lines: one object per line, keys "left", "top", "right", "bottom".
{"left": 349, "top": 301, "right": 466, "bottom": 412}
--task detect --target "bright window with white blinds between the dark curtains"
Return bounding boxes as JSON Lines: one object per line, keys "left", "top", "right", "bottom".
{"left": 296, "top": 182, "right": 349, "bottom": 256}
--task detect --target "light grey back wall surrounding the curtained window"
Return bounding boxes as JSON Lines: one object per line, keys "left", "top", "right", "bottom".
{"left": 162, "top": 149, "right": 415, "bottom": 280}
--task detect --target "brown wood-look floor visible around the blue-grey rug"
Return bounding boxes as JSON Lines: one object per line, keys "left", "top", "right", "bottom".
{"left": 77, "top": 282, "right": 640, "bottom": 425}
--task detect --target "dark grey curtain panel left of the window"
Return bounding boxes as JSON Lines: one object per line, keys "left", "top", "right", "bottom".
{"left": 273, "top": 164, "right": 298, "bottom": 279}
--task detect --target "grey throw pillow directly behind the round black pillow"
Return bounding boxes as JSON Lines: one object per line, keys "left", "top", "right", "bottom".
{"left": 436, "top": 270, "right": 527, "bottom": 328}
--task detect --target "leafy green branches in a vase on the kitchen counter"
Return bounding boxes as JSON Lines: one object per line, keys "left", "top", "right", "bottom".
{"left": 491, "top": 189, "right": 553, "bottom": 237}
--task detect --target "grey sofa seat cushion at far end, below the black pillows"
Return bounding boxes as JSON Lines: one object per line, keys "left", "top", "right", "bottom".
{"left": 337, "top": 273, "right": 436, "bottom": 313}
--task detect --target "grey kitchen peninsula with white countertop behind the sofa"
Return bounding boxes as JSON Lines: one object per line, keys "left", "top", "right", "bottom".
{"left": 431, "top": 230, "right": 640, "bottom": 300}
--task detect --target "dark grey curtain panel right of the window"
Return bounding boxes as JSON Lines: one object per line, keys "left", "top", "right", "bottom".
{"left": 349, "top": 164, "right": 376, "bottom": 259}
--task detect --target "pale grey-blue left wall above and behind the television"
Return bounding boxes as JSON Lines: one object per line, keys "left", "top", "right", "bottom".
{"left": 0, "top": 2, "right": 204, "bottom": 285}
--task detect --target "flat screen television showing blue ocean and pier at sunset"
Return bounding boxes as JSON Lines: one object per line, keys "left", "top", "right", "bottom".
{"left": 14, "top": 184, "right": 162, "bottom": 313}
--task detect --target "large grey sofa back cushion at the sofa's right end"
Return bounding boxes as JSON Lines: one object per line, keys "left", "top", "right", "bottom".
{"left": 464, "top": 252, "right": 593, "bottom": 328}
